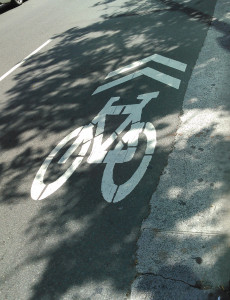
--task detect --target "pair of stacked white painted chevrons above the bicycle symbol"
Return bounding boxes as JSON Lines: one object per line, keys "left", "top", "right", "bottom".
{"left": 93, "top": 54, "right": 187, "bottom": 95}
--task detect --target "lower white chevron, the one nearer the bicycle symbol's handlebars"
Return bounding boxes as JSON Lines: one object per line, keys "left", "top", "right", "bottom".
{"left": 93, "top": 67, "right": 181, "bottom": 95}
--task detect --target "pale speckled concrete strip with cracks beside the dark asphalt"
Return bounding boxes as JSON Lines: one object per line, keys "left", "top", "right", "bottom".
{"left": 131, "top": 0, "right": 230, "bottom": 300}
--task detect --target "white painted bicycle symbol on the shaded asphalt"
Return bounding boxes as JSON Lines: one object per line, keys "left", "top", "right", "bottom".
{"left": 31, "top": 92, "right": 159, "bottom": 203}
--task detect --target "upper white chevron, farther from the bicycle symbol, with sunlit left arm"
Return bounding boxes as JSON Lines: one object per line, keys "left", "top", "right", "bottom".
{"left": 105, "top": 54, "right": 187, "bottom": 79}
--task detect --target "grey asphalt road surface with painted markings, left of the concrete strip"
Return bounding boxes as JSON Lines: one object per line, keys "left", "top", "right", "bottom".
{"left": 0, "top": 0, "right": 216, "bottom": 300}
